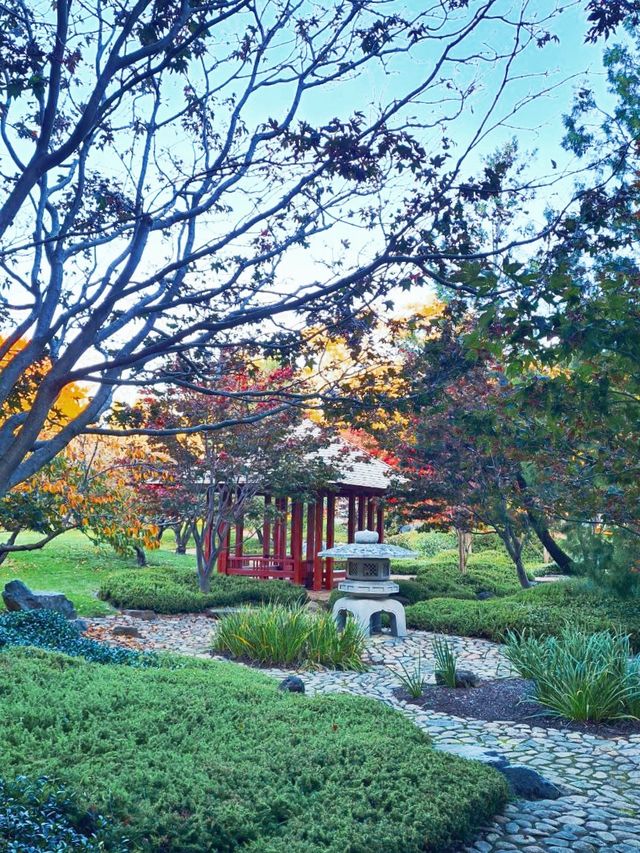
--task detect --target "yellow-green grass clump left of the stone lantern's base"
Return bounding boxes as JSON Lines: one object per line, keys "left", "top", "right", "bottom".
{"left": 213, "top": 604, "right": 365, "bottom": 671}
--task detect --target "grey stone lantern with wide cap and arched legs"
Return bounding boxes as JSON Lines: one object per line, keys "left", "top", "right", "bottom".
{"left": 318, "top": 530, "right": 417, "bottom": 637}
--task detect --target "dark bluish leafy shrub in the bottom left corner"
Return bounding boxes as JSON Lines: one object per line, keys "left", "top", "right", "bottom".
{"left": 0, "top": 776, "right": 128, "bottom": 853}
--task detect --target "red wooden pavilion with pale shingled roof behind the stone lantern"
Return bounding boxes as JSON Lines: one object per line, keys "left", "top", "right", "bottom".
{"left": 217, "top": 444, "right": 393, "bottom": 590}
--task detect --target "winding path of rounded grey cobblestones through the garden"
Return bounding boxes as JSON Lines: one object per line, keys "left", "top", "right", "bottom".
{"left": 90, "top": 616, "right": 640, "bottom": 853}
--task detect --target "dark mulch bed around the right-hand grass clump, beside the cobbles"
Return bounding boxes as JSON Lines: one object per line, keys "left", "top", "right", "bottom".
{"left": 396, "top": 678, "right": 640, "bottom": 737}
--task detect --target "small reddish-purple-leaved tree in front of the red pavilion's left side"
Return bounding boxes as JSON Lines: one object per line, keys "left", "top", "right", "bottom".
{"left": 133, "top": 354, "right": 336, "bottom": 592}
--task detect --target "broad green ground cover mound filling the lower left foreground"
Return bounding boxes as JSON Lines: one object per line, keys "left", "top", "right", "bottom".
{"left": 0, "top": 649, "right": 507, "bottom": 853}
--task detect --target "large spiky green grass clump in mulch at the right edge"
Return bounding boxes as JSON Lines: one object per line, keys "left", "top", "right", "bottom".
{"left": 505, "top": 628, "right": 640, "bottom": 722}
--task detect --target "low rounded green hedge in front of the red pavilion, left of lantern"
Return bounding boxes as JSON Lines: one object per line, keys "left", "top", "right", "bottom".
{"left": 98, "top": 566, "right": 307, "bottom": 613}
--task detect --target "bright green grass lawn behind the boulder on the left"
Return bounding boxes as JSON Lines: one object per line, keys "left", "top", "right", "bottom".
{"left": 0, "top": 530, "right": 195, "bottom": 616}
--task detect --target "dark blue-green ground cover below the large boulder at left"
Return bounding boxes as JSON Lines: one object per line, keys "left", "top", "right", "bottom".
{"left": 0, "top": 610, "right": 159, "bottom": 667}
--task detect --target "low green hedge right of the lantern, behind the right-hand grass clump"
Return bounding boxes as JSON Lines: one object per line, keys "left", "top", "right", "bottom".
{"left": 407, "top": 580, "right": 640, "bottom": 650}
